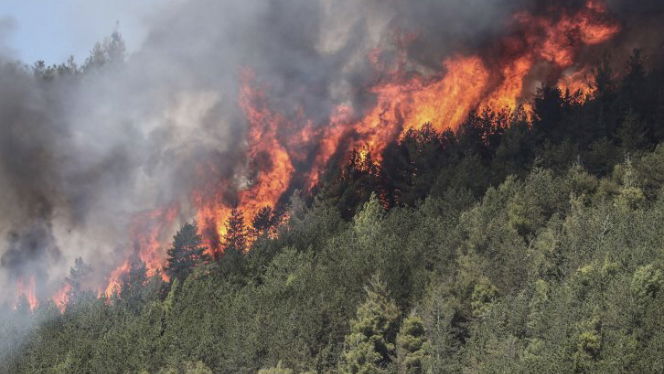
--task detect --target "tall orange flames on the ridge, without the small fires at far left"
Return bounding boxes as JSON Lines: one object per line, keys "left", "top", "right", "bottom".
{"left": 180, "top": 1, "right": 619, "bottom": 266}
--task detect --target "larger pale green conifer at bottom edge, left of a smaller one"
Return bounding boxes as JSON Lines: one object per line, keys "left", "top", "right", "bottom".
{"left": 339, "top": 276, "right": 400, "bottom": 374}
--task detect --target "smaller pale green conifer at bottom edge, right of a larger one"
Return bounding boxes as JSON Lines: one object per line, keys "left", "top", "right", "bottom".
{"left": 397, "top": 314, "right": 430, "bottom": 374}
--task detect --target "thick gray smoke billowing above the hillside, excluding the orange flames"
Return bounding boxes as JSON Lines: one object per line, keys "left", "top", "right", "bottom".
{"left": 0, "top": 0, "right": 664, "bottom": 312}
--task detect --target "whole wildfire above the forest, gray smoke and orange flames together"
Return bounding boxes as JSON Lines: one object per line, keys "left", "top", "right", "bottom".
{"left": 0, "top": 0, "right": 660, "bottom": 310}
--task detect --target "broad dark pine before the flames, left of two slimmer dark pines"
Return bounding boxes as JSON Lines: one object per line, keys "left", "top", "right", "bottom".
{"left": 166, "top": 223, "right": 208, "bottom": 281}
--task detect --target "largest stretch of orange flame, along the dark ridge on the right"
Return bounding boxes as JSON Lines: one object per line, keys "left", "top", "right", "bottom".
{"left": 308, "top": 0, "right": 620, "bottom": 172}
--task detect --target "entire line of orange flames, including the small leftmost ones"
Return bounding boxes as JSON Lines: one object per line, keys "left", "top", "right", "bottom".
{"left": 9, "top": 0, "right": 620, "bottom": 310}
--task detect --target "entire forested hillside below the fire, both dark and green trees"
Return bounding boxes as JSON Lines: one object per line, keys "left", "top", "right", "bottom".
{"left": 0, "top": 42, "right": 664, "bottom": 374}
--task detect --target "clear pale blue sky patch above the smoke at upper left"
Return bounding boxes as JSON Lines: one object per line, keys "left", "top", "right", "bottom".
{"left": 0, "top": 0, "right": 163, "bottom": 64}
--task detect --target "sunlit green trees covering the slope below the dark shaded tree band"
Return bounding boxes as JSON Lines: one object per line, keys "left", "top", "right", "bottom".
{"left": 13, "top": 145, "right": 664, "bottom": 373}
